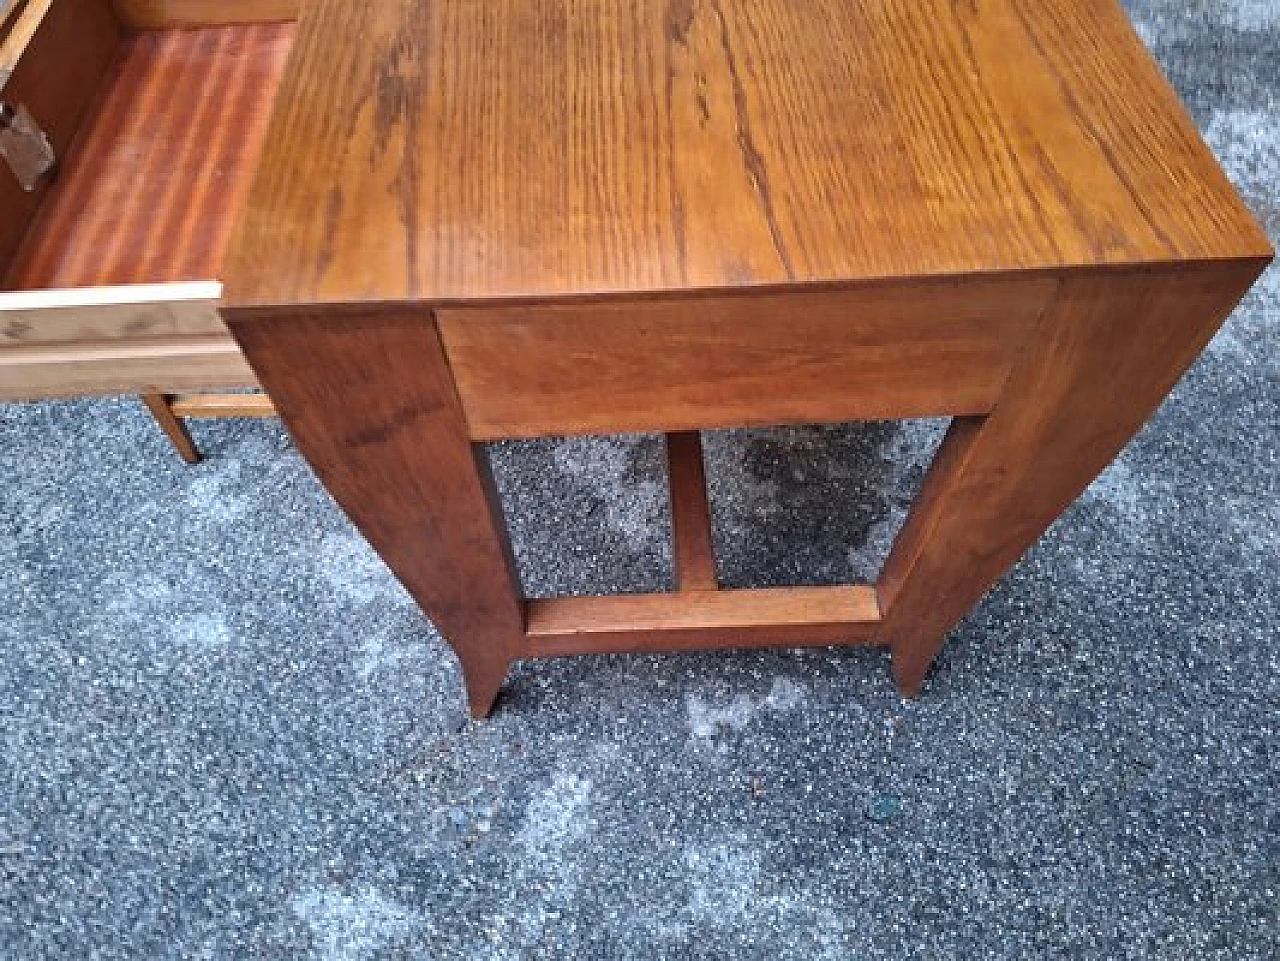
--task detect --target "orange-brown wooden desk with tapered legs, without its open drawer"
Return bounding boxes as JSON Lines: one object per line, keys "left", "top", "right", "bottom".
{"left": 223, "top": 0, "right": 1272, "bottom": 714}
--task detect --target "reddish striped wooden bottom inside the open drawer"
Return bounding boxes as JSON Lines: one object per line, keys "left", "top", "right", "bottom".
{"left": 6, "top": 22, "right": 293, "bottom": 289}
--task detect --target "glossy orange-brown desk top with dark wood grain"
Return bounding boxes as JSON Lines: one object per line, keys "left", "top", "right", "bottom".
{"left": 225, "top": 0, "right": 1270, "bottom": 306}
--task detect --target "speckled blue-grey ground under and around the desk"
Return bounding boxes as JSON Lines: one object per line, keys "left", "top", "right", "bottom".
{"left": 0, "top": 0, "right": 1280, "bottom": 961}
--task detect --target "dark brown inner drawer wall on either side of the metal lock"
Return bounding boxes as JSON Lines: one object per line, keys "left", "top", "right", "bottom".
{"left": 0, "top": 0, "right": 120, "bottom": 276}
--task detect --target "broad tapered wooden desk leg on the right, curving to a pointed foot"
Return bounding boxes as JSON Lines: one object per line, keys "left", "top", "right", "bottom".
{"left": 879, "top": 261, "right": 1265, "bottom": 696}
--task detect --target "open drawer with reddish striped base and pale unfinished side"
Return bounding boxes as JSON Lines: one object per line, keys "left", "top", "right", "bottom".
{"left": 0, "top": 0, "right": 296, "bottom": 399}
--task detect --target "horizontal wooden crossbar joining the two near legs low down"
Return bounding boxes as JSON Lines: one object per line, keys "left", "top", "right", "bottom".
{"left": 525, "top": 585, "right": 881, "bottom": 658}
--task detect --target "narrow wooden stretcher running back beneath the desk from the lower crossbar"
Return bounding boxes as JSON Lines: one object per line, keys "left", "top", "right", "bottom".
{"left": 667, "top": 430, "right": 719, "bottom": 591}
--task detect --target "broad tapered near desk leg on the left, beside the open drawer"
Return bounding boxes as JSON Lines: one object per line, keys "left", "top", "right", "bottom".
{"left": 227, "top": 307, "right": 524, "bottom": 717}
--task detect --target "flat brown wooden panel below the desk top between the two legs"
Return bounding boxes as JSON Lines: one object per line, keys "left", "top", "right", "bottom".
{"left": 436, "top": 278, "right": 1057, "bottom": 440}
